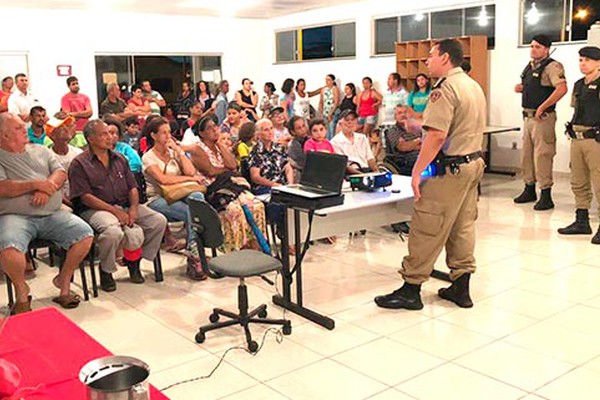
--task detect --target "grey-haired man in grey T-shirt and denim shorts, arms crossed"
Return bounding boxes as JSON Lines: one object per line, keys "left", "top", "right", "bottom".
{"left": 0, "top": 113, "right": 93, "bottom": 314}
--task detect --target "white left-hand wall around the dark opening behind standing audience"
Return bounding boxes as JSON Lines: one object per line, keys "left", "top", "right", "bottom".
{"left": 0, "top": 9, "right": 268, "bottom": 119}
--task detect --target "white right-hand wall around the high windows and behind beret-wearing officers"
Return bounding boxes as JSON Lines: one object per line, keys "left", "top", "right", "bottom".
{"left": 266, "top": 0, "right": 581, "bottom": 172}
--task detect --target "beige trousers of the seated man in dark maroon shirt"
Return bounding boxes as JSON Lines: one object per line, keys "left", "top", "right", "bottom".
{"left": 81, "top": 205, "right": 167, "bottom": 273}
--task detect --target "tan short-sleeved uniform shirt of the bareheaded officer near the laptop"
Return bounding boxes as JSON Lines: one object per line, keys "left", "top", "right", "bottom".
{"left": 423, "top": 67, "right": 487, "bottom": 156}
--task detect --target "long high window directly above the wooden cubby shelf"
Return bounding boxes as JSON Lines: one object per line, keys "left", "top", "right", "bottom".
{"left": 374, "top": 0, "right": 494, "bottom": 54}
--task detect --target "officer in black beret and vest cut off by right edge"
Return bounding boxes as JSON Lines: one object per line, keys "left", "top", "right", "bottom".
{"left": 558, "top": 46, "right": 600, "bottom": 244}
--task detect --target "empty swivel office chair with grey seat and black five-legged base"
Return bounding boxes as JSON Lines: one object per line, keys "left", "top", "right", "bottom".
{"left": 188, "top": 200, "right": 292, "bottom": 352}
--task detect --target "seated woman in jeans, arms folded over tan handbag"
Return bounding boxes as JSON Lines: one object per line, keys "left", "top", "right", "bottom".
{"left": 142, "top": 118, "right": 206, "bottom": 280}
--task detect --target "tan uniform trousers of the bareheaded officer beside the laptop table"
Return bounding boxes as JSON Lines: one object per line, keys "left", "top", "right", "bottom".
{"left": 400, "top": 159, "right": 485, "bottom": 284}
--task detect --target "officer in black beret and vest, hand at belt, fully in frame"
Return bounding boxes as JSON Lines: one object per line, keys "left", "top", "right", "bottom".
{"left": 514, "top": 35, "right": 567, "bottom": 211}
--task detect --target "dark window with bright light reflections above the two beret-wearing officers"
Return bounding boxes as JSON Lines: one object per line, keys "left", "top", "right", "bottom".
{"left": 521, "top": 0, "right": 600, "bottom": 45}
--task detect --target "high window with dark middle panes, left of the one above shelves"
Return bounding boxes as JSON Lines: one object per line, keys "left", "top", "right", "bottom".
{"left": 275, "top": 22, "right": 356, "bottom": 62}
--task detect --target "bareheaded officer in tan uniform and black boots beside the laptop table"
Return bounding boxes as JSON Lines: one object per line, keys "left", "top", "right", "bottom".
{"left": 375, "top": 39, "right": 487, "bottom": 310}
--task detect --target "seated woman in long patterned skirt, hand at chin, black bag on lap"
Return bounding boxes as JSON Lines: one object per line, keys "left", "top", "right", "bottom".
{"left": 191, "top": 116, "right": 266, "bottom": 251}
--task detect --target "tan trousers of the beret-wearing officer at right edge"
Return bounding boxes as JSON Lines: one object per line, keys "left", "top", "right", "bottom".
{"left": 571, "top": 139, "right": 600, "bottom": 212}
